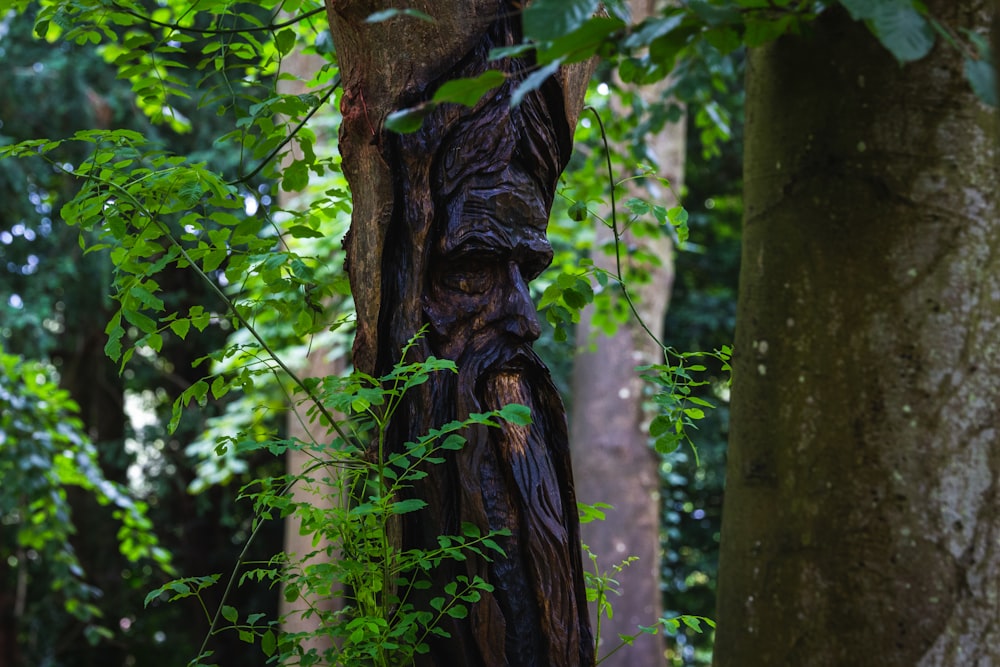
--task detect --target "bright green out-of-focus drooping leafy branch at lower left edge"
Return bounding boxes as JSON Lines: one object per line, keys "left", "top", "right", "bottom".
{"left": 0, "top": 349, "right": 173, "bottom": 640}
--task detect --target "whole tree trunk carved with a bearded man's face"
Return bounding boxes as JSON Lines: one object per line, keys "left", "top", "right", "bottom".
{"left": 327, "top": 0, "right": 593, "bottom": 667}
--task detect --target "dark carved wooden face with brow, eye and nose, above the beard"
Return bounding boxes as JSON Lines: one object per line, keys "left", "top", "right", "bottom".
{"left": 423, "top": 167, "right": 552, "bottom": 361}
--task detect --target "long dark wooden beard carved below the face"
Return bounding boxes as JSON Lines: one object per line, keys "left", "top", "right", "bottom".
{"left": 397, "top": 332, "right": 594, "bottom": 667}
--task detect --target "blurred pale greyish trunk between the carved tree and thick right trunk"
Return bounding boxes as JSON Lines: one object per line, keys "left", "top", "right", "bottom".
{"left": 570, "top": 0, "right": 685, "bottom": 667}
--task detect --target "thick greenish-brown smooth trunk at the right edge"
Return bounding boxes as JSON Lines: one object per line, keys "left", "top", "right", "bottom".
{"left": 715, "top": 5, "right": 1000, "bottom": 667}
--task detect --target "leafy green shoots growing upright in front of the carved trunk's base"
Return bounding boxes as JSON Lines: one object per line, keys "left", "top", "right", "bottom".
{"left": 146, "top": 354, "right": 530, "bottom": 665}
